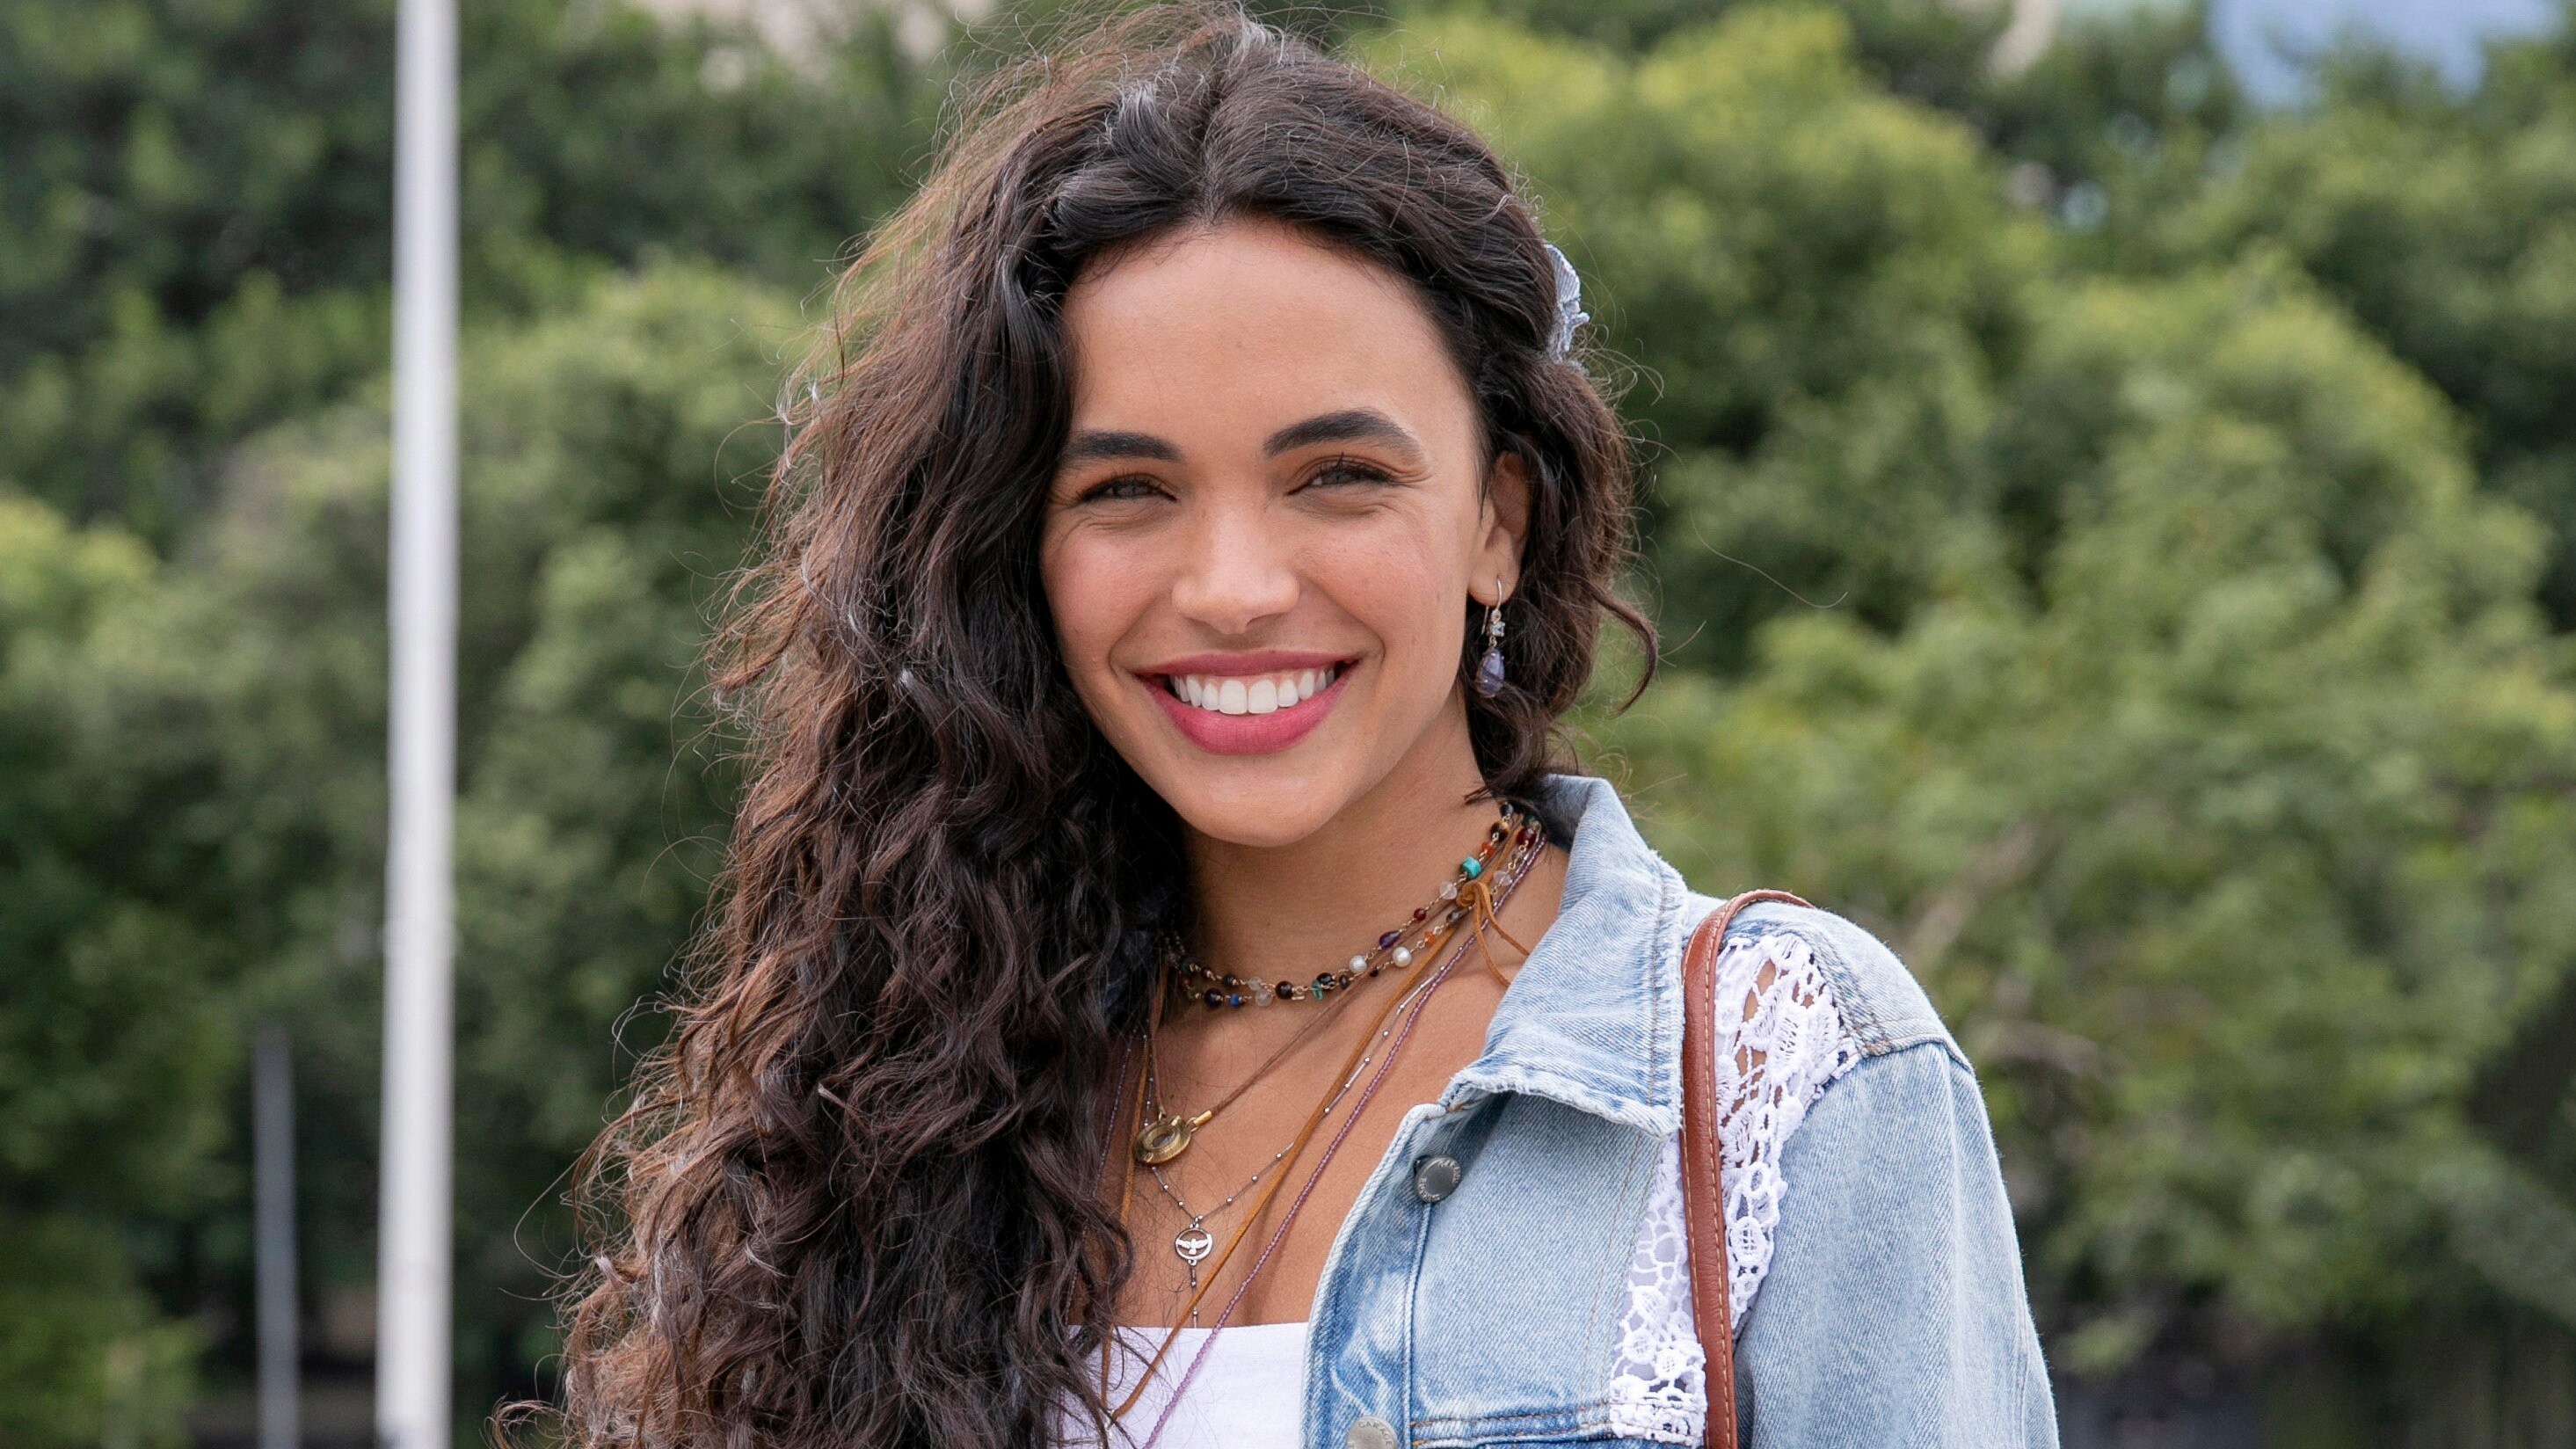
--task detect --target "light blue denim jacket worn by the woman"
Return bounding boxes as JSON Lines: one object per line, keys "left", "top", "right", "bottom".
{"left": 1304, "top": 776, "right": 2056, "bottom": 1449}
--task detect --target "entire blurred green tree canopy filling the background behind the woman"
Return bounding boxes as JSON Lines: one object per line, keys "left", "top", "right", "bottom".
{"left": 0, "top": 0, "right": 2576, "bottom": 1446}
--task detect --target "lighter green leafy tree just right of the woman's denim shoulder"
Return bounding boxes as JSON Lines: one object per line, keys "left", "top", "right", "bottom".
{"left": 1612, "top": 256, "right": 2576, "bottom": 1372}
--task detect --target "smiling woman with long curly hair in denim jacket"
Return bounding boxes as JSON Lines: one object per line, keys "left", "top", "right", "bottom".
{"left": 567, "top": 8, "right": 2053, "bottom": 1449}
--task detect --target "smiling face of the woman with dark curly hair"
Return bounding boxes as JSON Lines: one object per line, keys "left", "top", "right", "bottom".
{"left": 1041, "top": 222, "right": 1527, "bottom": 846}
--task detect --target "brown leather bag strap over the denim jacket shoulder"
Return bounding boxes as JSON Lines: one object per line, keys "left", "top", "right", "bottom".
{"left": 1682, "top": 890, "right": 1806, "bottom": 1449}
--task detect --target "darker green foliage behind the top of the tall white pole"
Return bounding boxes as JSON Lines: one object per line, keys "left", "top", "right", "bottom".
{"left": 0, "top": 0, "right": 938, "bottom": 547}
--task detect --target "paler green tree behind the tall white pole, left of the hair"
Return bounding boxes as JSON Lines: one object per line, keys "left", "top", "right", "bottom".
{"left": 133, "top": 266, "right": 801, "bottom": 1408}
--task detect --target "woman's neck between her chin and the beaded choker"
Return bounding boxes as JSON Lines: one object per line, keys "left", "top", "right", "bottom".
{"left": 1190, "top": 711, "right": 1496, "bottom": 979}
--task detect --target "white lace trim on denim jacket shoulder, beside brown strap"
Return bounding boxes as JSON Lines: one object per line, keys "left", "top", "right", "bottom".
{"left": 1610, "top": 936, "right": 1859, "bottom": 1444}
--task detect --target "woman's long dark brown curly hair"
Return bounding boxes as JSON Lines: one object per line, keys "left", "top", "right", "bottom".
{"left": 557, "top": 0, "right": 1654, "bottom": 1449}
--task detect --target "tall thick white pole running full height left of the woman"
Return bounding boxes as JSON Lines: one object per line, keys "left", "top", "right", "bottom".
{"left": 376, "top": 0, "right": 456, "bottom": 1449}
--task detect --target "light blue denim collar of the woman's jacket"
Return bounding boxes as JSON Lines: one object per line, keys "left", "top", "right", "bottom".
{"left": 1440, "top": 776, "right": 1687, "bottom": 1137}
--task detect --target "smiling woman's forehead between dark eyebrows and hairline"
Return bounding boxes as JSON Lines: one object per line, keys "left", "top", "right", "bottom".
{"left": 1064, "top": 222, "right": 1476, "bottom": 454}
